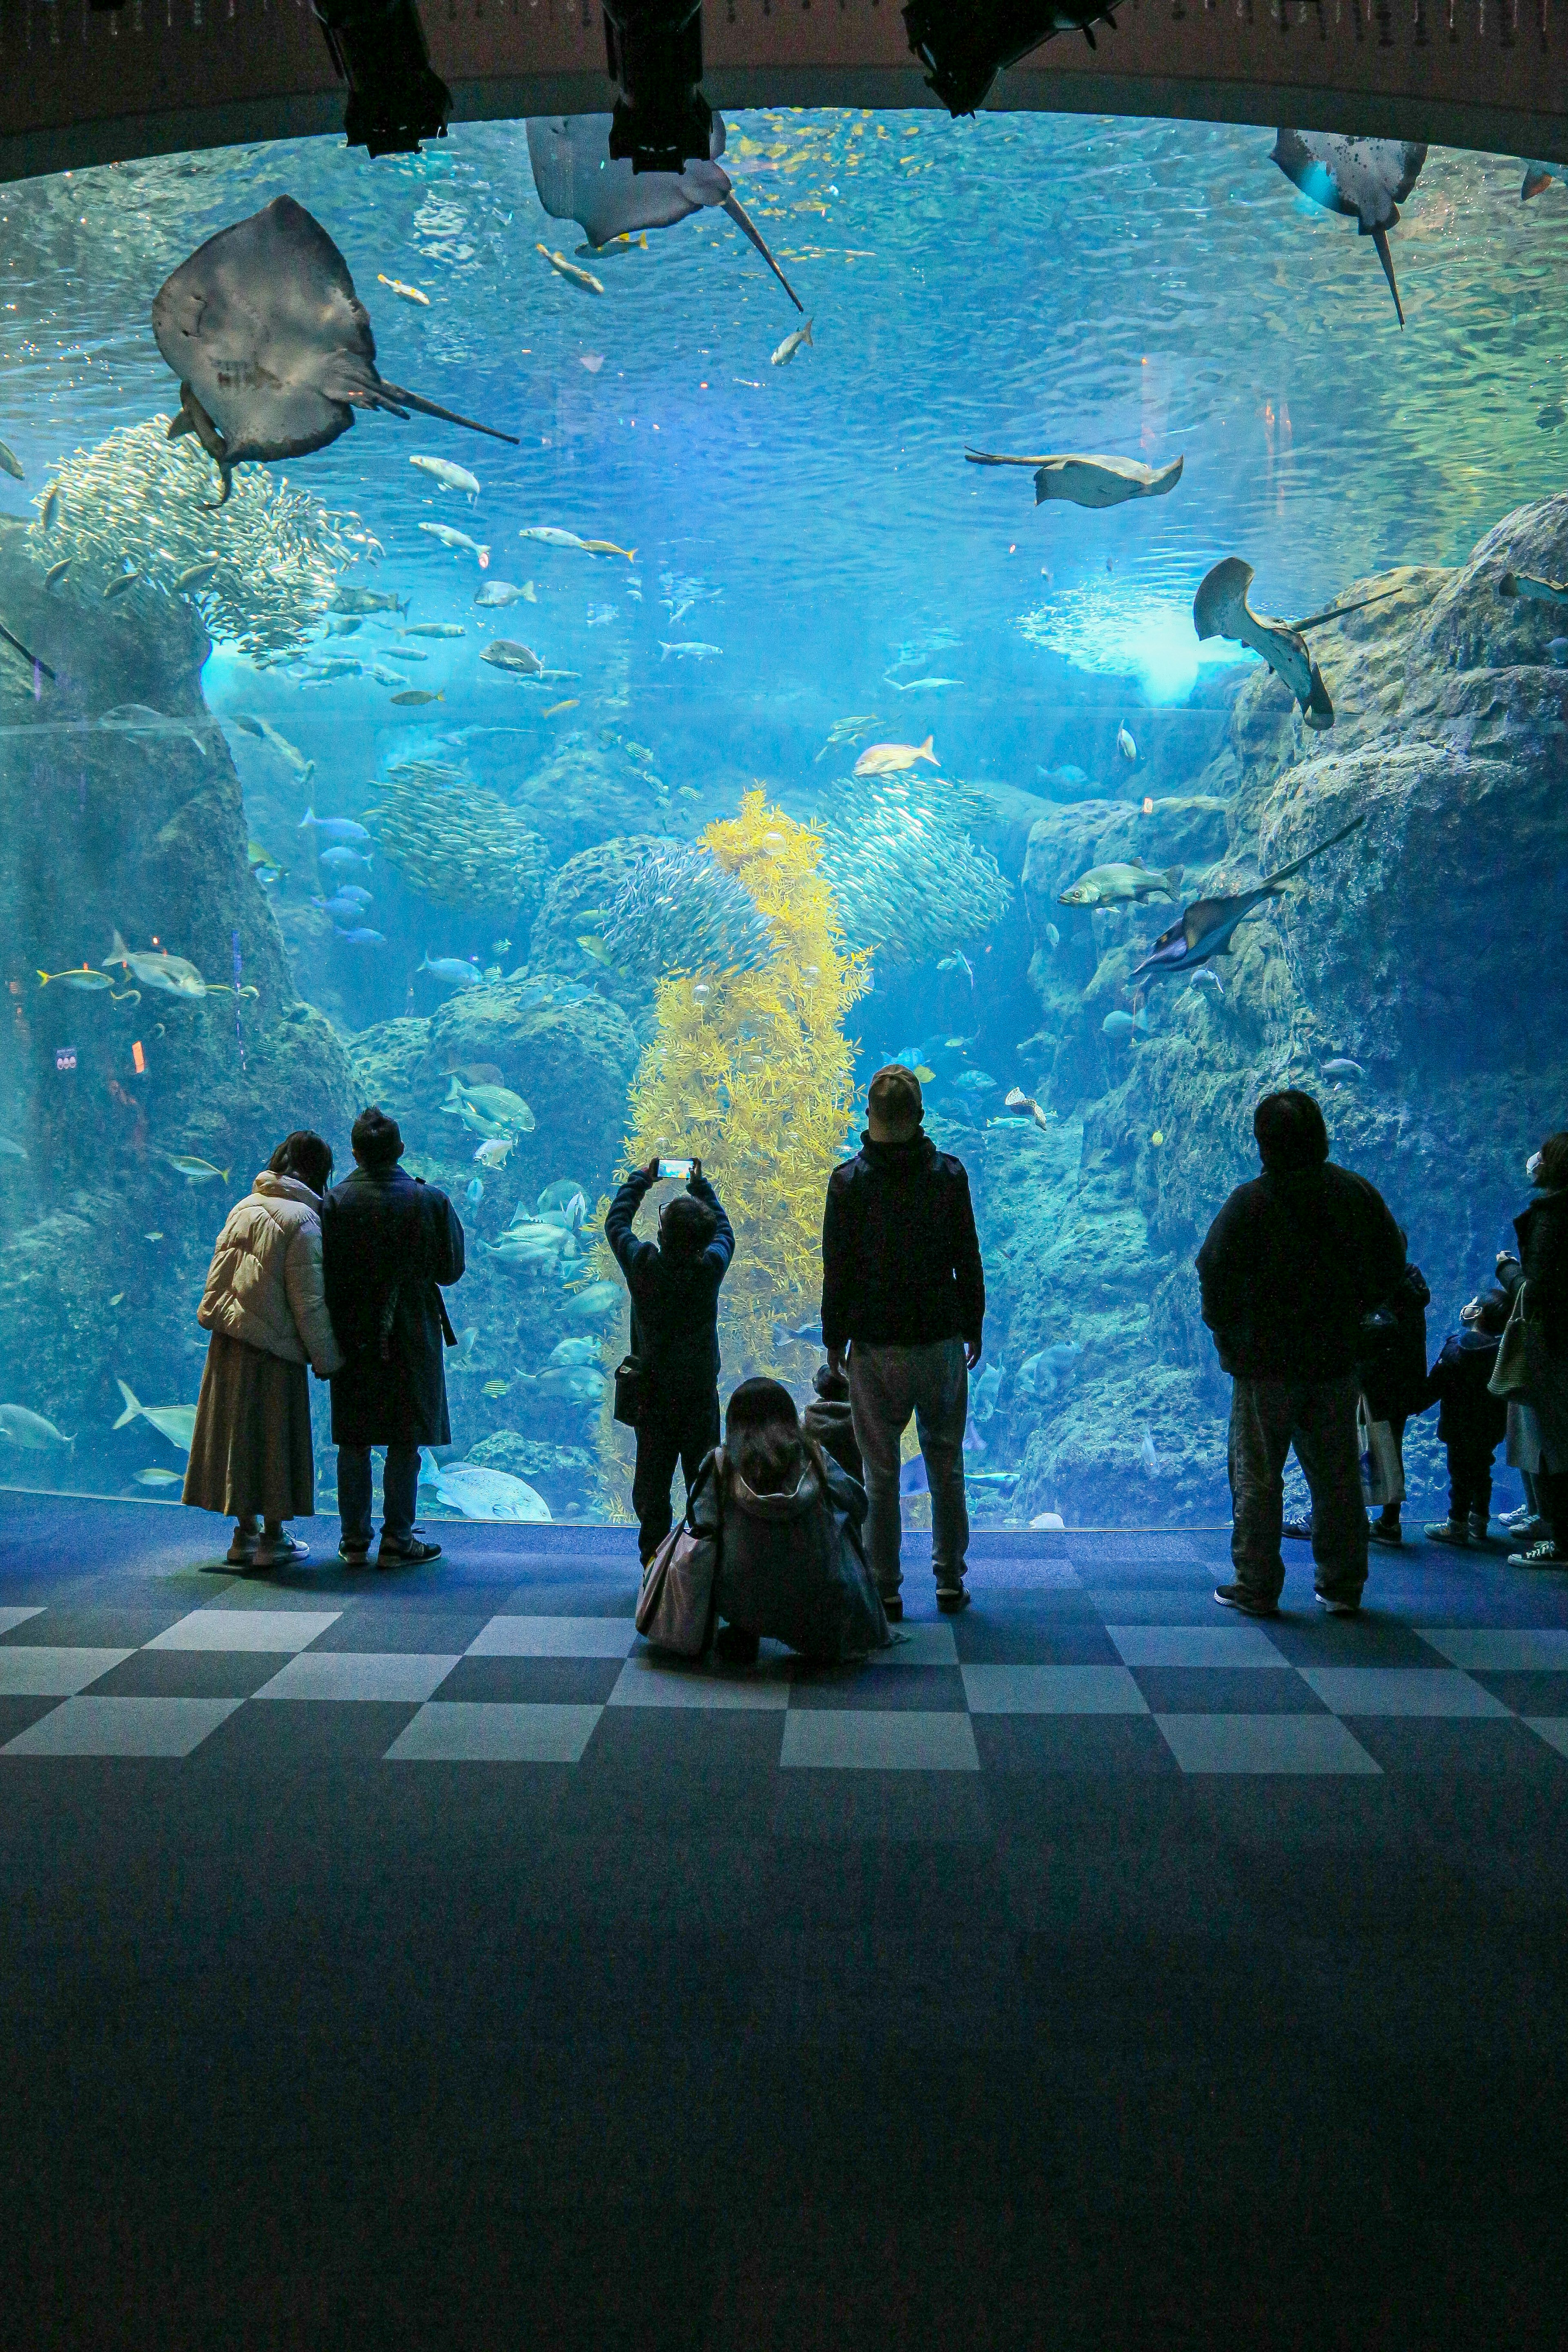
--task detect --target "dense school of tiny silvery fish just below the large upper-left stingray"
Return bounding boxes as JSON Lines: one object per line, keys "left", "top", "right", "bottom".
{"left": 33, "top": 416, "right": 381, "bottom": 654}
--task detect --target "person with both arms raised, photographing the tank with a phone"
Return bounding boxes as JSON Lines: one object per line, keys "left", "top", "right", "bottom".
{"left": 604, "top": 1160, "right": 736, "bottom": 1566}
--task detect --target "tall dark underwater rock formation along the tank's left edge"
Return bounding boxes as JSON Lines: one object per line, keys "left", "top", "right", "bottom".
{"left": 0, "top": 524, "right": 350, "bottom": 1484}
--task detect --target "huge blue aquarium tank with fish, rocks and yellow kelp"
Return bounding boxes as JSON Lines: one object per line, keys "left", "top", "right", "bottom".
{"left": 0, "top": 111, "right": 1568, "bottom": 1526}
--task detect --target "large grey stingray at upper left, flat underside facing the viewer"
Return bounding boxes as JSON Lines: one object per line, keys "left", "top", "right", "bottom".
{"left": 153, "top": 195, "right": 517, "bottom": 506}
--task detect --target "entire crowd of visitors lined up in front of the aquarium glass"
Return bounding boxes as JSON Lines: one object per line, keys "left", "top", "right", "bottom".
{"left": 183, "top": 1063, "right": 1568, "bottom": 1663}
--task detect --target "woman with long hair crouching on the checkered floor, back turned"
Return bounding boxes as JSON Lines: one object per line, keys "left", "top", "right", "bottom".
{"left": 691, "top": 1381, "right": 893, "bottom": 1665}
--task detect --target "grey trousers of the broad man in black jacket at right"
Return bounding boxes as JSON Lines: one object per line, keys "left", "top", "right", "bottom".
{"left": 1229, "top": 1374, "right": 1366, "bottom": 1602}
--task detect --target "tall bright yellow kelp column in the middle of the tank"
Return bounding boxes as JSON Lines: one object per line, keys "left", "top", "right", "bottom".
{"left": 604, "top": 790, "right": 865, "bottom": 1515}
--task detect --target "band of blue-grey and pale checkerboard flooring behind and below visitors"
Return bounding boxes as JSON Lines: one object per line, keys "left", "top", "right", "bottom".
{"left": 0, "top": 1590, "right": 1568, "bottom": 1776}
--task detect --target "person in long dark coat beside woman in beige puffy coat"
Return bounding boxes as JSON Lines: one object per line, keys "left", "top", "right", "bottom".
{"left": 322, "top": 1108, "right": 463, "bottom": 1569}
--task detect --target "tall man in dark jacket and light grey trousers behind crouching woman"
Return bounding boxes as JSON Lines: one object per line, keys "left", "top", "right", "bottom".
{"left": 823, "top": 1063, "right": 985, "bottom": 1618}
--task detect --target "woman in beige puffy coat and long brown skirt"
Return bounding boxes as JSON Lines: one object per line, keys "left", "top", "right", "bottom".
{"left": 183, "top": 1129, "right": 343, "bottom": 1569}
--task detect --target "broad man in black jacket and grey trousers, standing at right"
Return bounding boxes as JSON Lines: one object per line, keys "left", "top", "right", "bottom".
{"left": 1196, "top": 1087, "right": 1406, "bottom": 1616}
